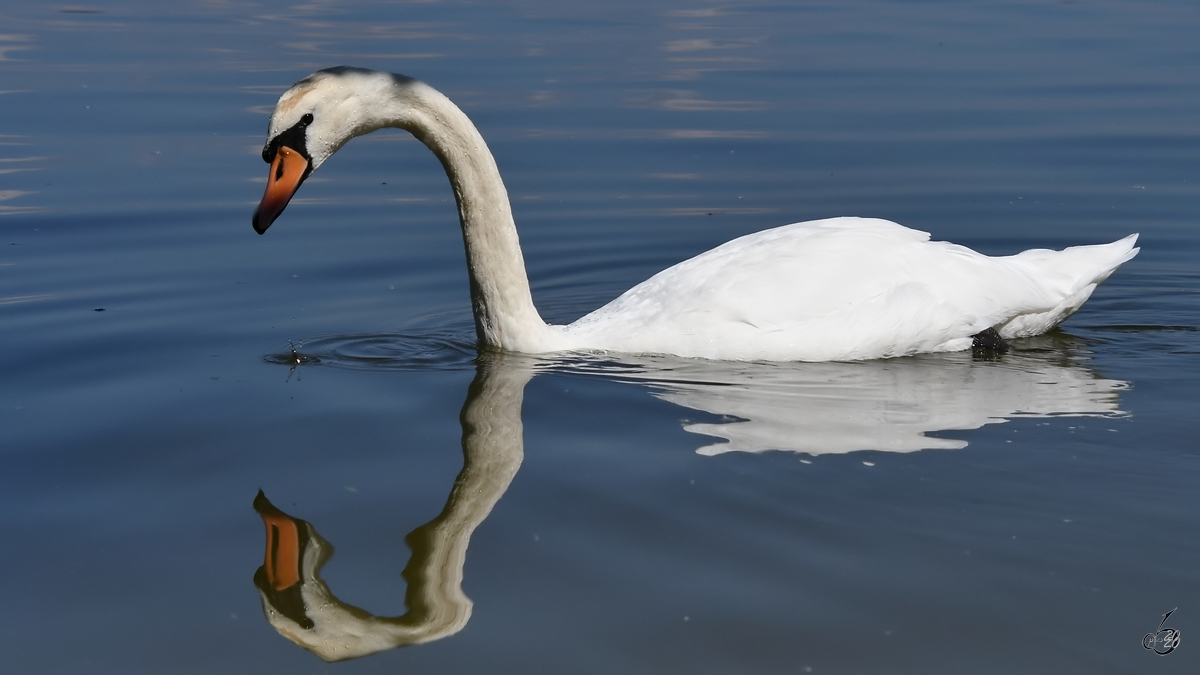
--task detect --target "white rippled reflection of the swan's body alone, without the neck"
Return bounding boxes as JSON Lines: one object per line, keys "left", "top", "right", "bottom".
{"left": 633, "top": 353, "right": 1128, "bottom": 455}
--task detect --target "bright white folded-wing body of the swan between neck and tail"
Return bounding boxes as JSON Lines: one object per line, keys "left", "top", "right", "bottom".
{"left": 566, "top": 217, "right": 1064, "bottom": 360}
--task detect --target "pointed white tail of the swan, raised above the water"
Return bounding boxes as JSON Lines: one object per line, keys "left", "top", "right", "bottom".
{"left": 996, "top": 234, "right": 1140, "bottom": 339}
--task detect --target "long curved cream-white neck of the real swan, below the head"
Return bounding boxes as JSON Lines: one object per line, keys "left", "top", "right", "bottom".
{"left": 388, "top": 80, "right": 548, "bottom": 352}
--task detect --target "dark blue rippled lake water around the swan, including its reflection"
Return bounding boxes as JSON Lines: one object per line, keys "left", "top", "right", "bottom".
{"left": 0, "top": 0, "right": 1200, "bottom": 674}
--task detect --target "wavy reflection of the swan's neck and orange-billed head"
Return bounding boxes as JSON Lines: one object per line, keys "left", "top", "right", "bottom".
{"left": 254, "top": 356, "right": 533, "bottom": 661}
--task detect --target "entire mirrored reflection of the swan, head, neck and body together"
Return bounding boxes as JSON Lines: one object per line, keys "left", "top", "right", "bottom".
{"left": 254, "top": 338, "right": 1128, "bottom": 661}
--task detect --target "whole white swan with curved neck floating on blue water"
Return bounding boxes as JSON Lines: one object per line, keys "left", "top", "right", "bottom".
{"left": 253, "top": 66, "right": 1138, "bottom": 362}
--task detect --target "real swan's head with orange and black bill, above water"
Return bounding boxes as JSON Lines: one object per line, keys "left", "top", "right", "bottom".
{"left": 253, "top": 66, "right": 416, "bottom": 234}
